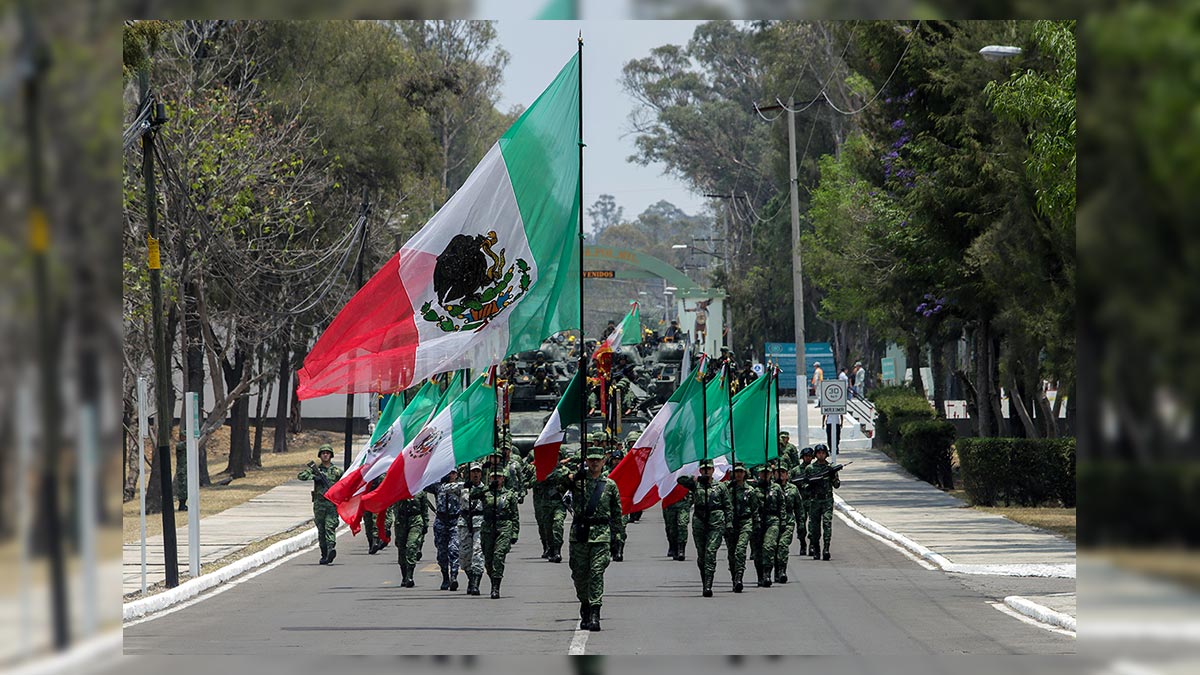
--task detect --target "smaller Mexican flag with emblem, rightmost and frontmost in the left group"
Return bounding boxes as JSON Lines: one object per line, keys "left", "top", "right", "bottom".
{"left": 362, "top": 374, "right": 496, "bottom": 513}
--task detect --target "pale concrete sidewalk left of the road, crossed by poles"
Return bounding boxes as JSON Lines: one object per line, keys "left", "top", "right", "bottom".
{"left": 121, "top": 480, "right": 312, "bottom": 597}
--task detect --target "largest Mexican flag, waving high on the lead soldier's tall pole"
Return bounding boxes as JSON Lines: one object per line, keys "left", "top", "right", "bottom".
{"left": 298, "top": 55, "right": 580, "bottom": 399}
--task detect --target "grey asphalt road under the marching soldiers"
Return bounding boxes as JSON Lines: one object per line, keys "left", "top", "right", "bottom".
{"left": 125, "top": 500, "right": 1075, "bottom": 656}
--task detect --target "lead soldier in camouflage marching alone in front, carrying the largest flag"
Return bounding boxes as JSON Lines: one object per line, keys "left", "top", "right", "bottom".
{"left": 559, "top": 447, "right": 620, "bottom": 631}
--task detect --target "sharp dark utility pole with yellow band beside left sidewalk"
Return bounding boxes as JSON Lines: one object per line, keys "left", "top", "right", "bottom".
{"left": 138, "top": 71, "right": 177, "bottom": 589}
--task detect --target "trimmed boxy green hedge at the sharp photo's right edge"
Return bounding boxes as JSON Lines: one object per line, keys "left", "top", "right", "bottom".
{"left": 956, "top": 438, "right": 1075, "bottom": 507}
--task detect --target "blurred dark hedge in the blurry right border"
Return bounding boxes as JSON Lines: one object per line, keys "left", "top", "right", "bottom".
{"left": 1079, "top": 461, "right": 1200, "bottom": 546}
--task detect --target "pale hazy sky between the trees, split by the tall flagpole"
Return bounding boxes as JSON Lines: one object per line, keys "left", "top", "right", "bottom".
{"left": 484, "top": 15, "right": 706, "bottom": 227}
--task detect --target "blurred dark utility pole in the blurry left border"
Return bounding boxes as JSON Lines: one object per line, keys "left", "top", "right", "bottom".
{"left": 20, "top": 2, "right": 71, "bottom": 651}
